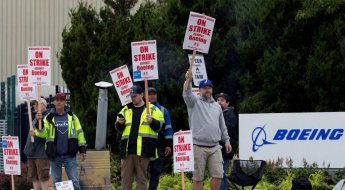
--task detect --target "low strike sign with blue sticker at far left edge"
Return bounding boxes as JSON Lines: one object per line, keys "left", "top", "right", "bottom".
{"left": 2, "top": 136, "right": 21, "bottom": 175}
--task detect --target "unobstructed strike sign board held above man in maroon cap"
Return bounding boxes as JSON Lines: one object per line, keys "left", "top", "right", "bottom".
{"left": 28, "top": 46, "right": 51, "bottom": 85}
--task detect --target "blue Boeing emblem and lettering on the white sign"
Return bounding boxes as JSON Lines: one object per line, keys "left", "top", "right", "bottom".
{"left": 252, "top": 125, "right": 344, "bottom": 152}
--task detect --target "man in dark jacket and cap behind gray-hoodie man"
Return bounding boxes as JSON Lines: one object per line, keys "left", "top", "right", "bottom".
{"left": 216, "top": 93, "right": 238, "bottom": 190}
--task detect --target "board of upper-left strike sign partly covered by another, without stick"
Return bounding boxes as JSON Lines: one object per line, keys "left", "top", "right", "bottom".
{"left": 17, "top": 65, "right": 37, "bottom": 101}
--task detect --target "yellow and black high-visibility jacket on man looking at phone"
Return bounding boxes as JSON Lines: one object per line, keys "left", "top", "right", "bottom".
{"left": 119, "top": 104, "right": 164, "bottom": 158}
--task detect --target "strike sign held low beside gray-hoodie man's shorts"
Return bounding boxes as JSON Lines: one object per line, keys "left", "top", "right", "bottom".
{"left": 173, "top": 130, "right": 194, "bottom": 173}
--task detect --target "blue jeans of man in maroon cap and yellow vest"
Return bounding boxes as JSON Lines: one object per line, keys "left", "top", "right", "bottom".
{"left": 50, "top": 156, "right": 80, "bottom": 190}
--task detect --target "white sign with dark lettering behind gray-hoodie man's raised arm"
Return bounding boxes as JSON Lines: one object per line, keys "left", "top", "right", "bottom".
{"left": 188, "top": 55, "right": 207, "bottom": 86}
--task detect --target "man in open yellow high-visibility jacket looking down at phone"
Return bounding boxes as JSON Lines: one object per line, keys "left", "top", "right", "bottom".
{"left": 115, "top": 85, "right": 164, "bottom": 190}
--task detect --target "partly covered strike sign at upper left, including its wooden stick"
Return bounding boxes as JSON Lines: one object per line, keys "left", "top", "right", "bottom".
{"left": 17, "top": 65, "right": 37, "bottom": 142}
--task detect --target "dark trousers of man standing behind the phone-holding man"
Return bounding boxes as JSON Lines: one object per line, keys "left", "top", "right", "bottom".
{"left": 149, "top": 147, "right": 165, "bottom": 190}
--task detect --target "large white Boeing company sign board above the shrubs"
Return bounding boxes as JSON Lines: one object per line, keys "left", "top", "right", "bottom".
{"left": 239, "top": 112, "right": 345, "bottom": 168}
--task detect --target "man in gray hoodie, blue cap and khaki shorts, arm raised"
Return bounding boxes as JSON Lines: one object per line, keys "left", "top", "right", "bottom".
{"left": 183, "top": 71, "right": 231, "bottom": 190}
